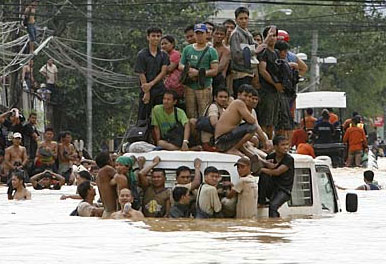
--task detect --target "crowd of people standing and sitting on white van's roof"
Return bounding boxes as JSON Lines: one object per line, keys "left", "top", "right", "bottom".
{"left": 129, "top": 7, "right": 307, "bottom": 172}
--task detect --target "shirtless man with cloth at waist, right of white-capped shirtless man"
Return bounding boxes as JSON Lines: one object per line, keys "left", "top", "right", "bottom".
{"left": 35, "top": 127, "right": 58, "bottom": 173}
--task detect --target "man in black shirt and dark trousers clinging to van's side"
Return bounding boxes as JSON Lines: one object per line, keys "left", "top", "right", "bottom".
{"left": 258, "top": 136, "right": 295, "bottom": 217}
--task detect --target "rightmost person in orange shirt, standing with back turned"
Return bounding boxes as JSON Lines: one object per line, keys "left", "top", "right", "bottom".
{"left": 343, "top": 115, "right": 368, "bottom": 167}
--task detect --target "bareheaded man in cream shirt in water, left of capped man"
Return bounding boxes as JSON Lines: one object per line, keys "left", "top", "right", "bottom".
{"left": 196, "top": 166, "right": 222, "bottom": 218}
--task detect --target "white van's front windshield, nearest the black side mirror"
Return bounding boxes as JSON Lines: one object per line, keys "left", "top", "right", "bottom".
{"left": 316, "top": 166, "right": 337, "bottom": 213}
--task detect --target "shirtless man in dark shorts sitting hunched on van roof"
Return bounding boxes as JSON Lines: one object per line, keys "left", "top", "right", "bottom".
{"left": 215, "top": 85, "right": 267, "bottom": 157}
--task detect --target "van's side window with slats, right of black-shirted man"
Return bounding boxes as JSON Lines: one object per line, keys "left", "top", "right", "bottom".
{"left": 288, "top": 168, "right": 313, "bottom": 206}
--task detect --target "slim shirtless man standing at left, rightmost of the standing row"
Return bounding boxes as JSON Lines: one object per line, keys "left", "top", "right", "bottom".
{"left": 58, "top": 132, "right": 77, "bottom": 185}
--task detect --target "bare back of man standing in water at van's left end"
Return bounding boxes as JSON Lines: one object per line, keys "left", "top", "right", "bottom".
{"left": 96, "top": 165, "right": 118, "bottom": 217}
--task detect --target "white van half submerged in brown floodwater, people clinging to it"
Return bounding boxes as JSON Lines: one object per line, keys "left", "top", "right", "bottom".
{"left": 125, "top": 151, "right": 356, "bottom": 217}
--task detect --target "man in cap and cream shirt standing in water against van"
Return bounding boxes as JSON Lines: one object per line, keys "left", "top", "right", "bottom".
{"left": 227, "top": 158, "right": 257, "bottom": 218}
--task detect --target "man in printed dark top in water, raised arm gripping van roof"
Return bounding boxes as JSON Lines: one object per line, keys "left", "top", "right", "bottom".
{"left": 138, "top": 156, "right": 170, "bottom": 217}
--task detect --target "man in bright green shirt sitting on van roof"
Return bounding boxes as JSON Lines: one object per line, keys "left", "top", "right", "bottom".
{"left": 151, "top": 90, "right": 190, "bottom": 150}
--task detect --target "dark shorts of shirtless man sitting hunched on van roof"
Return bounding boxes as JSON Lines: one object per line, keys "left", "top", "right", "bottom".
{"left": 215, "top": 123, "right": 257, "bottom": 151}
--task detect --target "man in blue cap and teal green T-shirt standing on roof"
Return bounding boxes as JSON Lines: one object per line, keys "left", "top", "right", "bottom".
{"left": 179, "top": 24, "right": 218, "bottom": 118}
